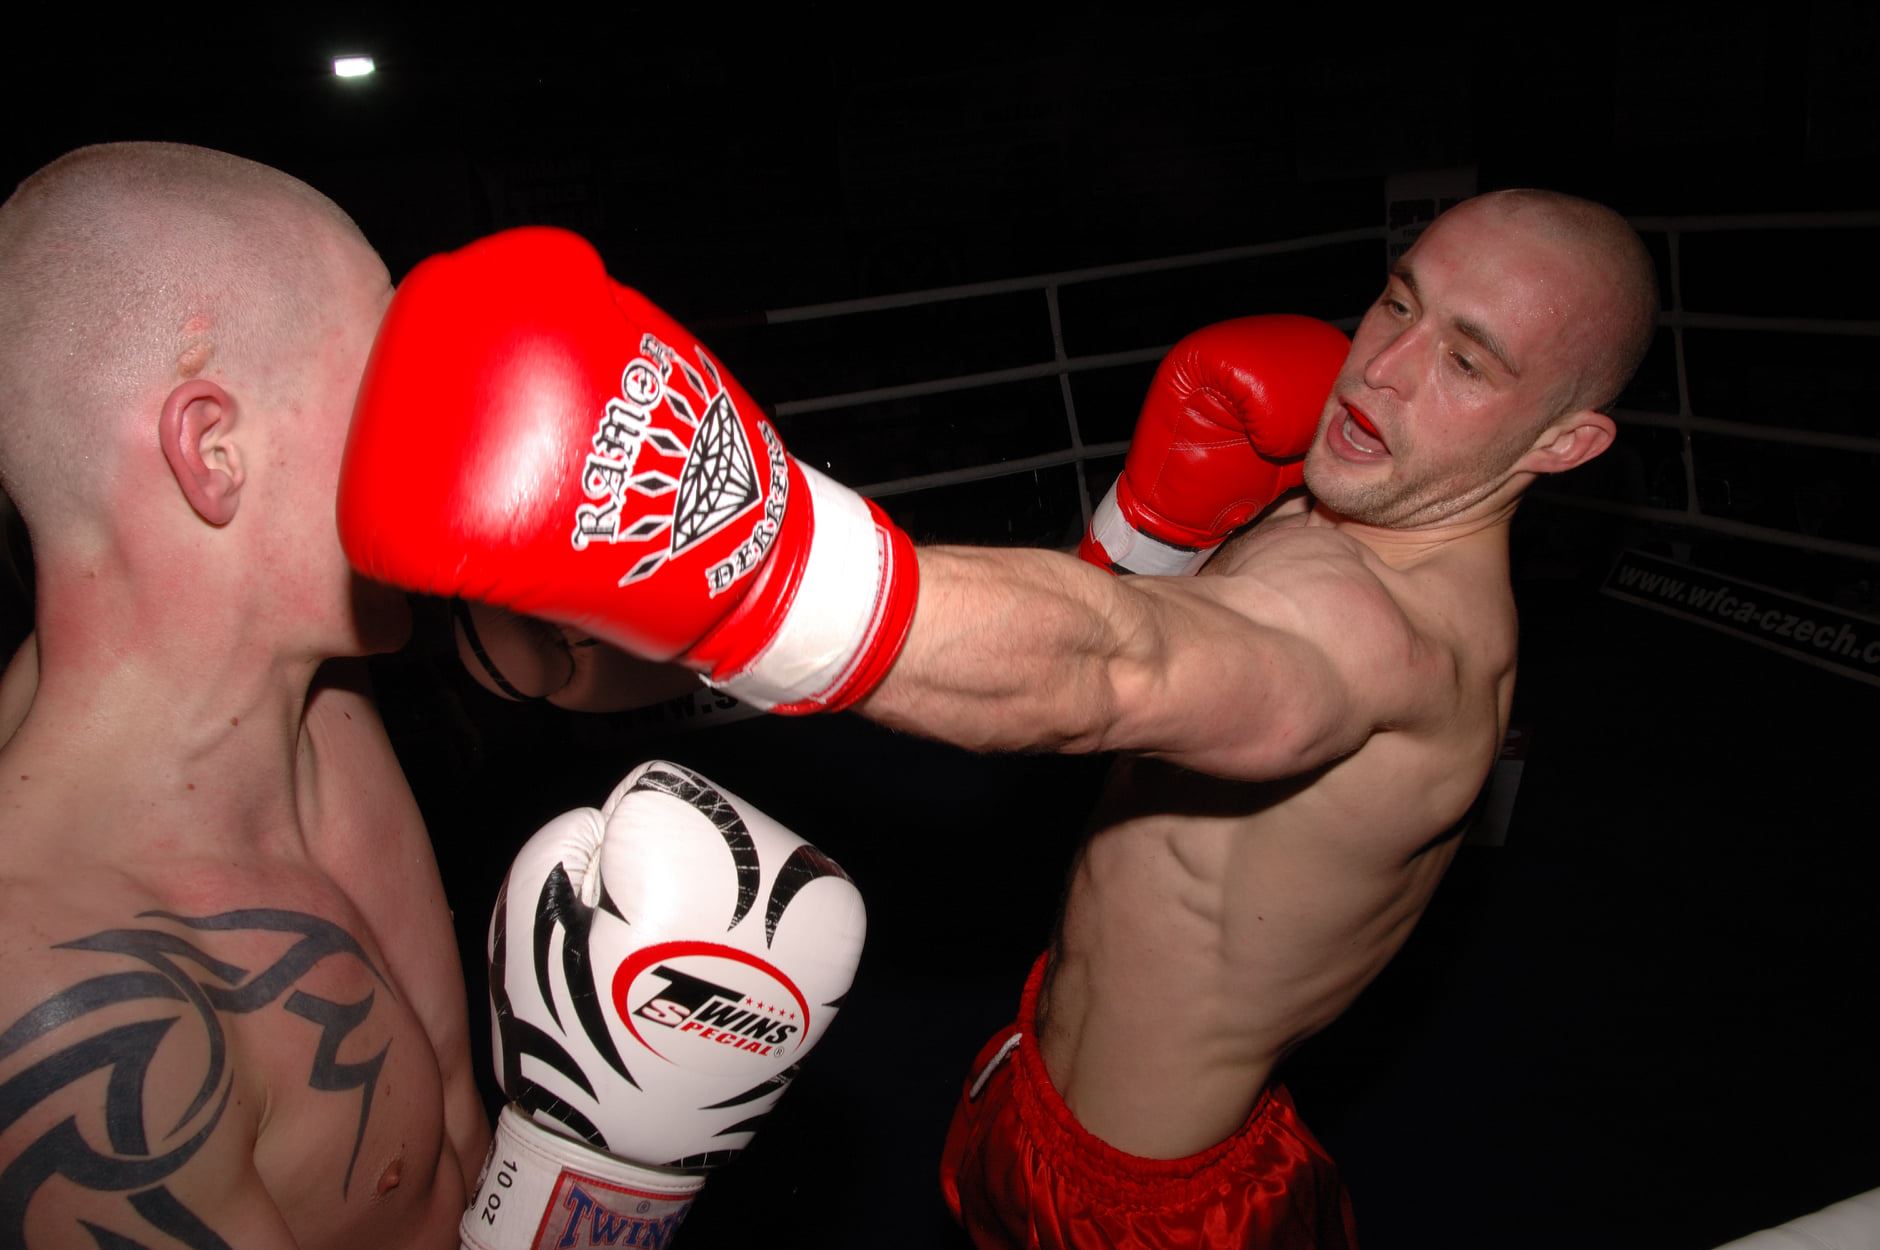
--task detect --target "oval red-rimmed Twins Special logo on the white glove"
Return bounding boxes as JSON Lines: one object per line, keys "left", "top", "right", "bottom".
{"left": 613, "top": 942, "right": 810, "bottom": 1071}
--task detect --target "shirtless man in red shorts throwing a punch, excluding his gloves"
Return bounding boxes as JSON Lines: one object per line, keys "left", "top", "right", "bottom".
{"left": 898, "top": 192, "right": 1656, "bottom": 1248}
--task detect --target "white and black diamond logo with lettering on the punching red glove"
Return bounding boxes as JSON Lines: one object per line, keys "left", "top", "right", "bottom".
{"left": 570, "top": 335, "right": 790, "bottom": 594}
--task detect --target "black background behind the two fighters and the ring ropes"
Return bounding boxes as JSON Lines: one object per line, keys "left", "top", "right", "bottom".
{"left": 0, "top": 4, "right": 1880, "bottom": 1250}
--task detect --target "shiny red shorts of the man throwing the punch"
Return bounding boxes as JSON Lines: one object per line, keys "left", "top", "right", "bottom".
{"left": 940, "top": 957, "right": 1357, "bottom": 1250}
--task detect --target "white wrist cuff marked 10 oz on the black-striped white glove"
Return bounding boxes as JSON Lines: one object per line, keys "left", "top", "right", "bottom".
{"left": 459, "top": 1105, "right": 705, "bottom": 1250}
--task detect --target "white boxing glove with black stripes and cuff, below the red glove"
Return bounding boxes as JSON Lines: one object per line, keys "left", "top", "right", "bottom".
{"left": 462, "top": 761, "right": 867, "bottom": 1250}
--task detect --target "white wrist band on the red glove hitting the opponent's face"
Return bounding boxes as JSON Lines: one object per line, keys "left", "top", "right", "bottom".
{"left": 707, "top": 462, "right": 889, "bottom": 711}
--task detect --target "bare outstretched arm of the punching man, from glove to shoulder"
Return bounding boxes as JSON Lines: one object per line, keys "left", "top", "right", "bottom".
{"left": 859, "top": 538, "right": 1455, "bottom": 780}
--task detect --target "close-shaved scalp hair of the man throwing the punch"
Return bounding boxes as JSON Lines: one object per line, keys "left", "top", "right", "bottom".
{"left": 1461, "top": 188, "right": 1658, "bottom": 417}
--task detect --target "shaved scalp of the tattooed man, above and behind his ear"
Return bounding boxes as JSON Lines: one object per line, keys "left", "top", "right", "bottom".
{"left": 0, "top": 143, "right": 377, "bottom": 547}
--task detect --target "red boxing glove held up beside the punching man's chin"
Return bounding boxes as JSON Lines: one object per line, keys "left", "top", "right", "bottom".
{"left": 1077, "top": 314, "right": 1350, "bottom": 573}
